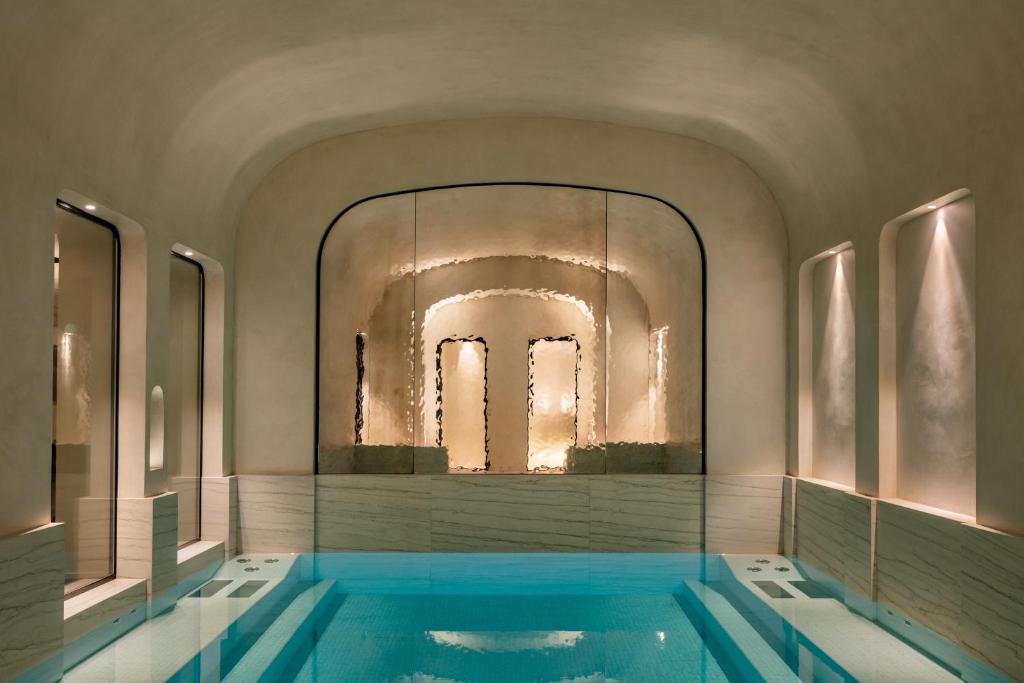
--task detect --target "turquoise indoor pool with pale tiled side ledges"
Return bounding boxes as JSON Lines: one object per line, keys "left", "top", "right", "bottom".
{"left": 56, "top": 553, "right": 1001, "bottom": 683}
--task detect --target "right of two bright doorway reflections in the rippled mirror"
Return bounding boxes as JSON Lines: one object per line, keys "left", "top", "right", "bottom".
{"left": 526, "top": 337, "right": 580, "bottom": 472}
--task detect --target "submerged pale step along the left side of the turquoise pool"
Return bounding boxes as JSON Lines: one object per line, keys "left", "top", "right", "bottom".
{"left": 224, "top": 581, "right": 335, "bottom": 683}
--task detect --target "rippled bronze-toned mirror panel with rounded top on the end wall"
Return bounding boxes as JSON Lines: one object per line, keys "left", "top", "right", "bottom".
{"left": 317, "top": 184, "right": 705, "bottom": 473}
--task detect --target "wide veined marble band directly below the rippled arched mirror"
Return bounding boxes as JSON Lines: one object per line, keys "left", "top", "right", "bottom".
{"left": 314, "top": 474, "right": 708, "bottom": 552}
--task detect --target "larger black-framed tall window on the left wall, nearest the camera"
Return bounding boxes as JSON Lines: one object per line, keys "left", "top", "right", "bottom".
{"left": 51, "top": 202, "right": 119, "bottom": 594}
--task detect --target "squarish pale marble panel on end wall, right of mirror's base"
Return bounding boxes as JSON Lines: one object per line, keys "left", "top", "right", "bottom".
{"left": 705, "top": 475, "right": 782, "bottom": 554}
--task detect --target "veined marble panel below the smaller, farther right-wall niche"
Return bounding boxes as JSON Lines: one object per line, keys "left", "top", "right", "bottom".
{"left": 796, "top": 479, "right": 847, "bottom": 583}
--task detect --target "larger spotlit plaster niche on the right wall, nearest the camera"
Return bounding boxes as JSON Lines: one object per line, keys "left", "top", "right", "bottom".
{"left": 880, "top": 190, "right": 976, "bottom": 516}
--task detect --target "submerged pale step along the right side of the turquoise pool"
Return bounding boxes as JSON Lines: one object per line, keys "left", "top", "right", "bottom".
{"left": 683, "top": 580, "right": 800, "bottom": 683}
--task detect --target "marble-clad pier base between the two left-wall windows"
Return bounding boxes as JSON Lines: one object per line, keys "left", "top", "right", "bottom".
{"left": 117, "top": 492, "right": 178, "bottom": 595}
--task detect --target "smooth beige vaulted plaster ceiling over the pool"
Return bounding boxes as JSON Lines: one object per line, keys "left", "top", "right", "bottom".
{"left": 0, "top": 0, "right": 1024, "bottom": 245}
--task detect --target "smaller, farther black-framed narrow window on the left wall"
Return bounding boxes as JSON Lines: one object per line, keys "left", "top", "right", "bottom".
{"left": 164, "top": 254, "right": 204, "bottom": 545}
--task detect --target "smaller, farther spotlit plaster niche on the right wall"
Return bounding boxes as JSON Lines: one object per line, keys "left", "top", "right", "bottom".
{"left": 800, "top": 243, "right": 857, "bottom": 487}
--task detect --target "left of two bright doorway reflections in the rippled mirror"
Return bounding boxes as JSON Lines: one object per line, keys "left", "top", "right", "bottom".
{"left": 437, "top": 337, "right": 487, "bottom": 470}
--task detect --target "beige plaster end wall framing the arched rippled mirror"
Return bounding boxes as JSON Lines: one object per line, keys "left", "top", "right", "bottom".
{"left": 234, "top": 119, "right": 785, "bottom": 473}
